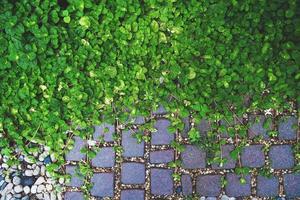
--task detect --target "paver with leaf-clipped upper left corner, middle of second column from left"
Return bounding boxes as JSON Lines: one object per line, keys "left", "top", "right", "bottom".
{"left": 92, "top": 147, "right": 115, "bottom": 167}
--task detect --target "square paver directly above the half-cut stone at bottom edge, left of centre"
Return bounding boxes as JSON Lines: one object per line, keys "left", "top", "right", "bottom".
{"left": 121, "top": 162, "right": 145, "bottom": 184}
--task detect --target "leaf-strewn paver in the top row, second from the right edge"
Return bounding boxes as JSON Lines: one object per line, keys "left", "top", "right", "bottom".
{"left": 248, "top": 115, "right": 271, "bottom": 139}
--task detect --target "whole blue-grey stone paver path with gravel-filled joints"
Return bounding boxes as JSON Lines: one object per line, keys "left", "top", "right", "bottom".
{"left": 64, "top": 112, "right": 300, "bottom": 200}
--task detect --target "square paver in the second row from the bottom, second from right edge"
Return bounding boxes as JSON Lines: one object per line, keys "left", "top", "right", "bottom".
{"left": 241, "top": 145, "right": 265, "bottom": 167}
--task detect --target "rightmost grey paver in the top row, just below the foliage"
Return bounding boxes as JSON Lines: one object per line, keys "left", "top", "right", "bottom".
{"left": 278, "top": 117, "right": 297, "bottom": 140}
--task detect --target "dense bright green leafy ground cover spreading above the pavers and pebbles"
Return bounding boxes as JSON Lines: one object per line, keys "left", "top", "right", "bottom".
{"left": 0, "top": 0, "right": 300, "bottom": 182}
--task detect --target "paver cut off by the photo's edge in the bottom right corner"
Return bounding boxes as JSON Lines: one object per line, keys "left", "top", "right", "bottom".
{"left": 283, "top": 173, "right": 300, "bottom": 198}
